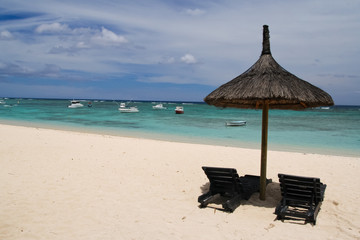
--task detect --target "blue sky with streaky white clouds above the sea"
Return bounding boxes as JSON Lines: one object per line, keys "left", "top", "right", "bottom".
{"left": 0, "top": 0, "right": 360, "bottom": 105}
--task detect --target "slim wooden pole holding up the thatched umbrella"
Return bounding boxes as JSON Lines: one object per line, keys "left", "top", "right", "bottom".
{"left": 260, "top": 101, "right": 269, "bottom": 200}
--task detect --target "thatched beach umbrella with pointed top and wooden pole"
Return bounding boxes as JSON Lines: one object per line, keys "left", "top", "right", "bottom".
{"left": 204, "top": 25, "right": 334, "bottom": 200}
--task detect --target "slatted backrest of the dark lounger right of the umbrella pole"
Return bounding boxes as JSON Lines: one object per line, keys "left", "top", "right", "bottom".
{"left": 278, "top": 174, "right": 324, "bottom": 204}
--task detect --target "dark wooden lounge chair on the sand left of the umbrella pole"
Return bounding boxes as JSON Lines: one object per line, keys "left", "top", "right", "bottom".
{"left": 198, "top": 167, "right": 271, "bottom": 212}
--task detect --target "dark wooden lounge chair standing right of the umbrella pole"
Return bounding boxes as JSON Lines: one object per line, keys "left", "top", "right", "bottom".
{"left": 275, "top": 174, "right": 326, "bottom": 225}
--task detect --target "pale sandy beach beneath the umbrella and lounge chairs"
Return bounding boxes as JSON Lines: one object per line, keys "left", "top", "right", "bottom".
{"left": 0, "top": 125, "right": 360, "bottom": 240}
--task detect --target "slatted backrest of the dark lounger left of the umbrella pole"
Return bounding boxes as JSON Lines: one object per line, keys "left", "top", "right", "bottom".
{"left": 202, "top": 167, "right": 241, "bottom": 194}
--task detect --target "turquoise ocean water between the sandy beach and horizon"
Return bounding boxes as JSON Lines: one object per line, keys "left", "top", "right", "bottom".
{"left": 0, "top": 99, "right": 360, "bottom": 157}
